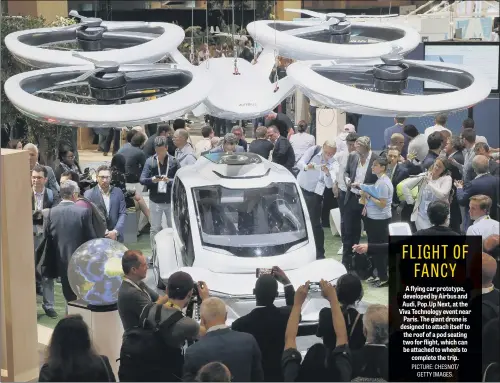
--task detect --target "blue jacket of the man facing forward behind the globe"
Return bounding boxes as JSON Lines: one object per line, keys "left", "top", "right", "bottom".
{"left": 84, "top": 186, "right": 127, "bottom": 242}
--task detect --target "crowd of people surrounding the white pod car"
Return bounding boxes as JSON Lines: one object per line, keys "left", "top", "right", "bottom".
{"left": 15, "top": 104, "right": 500, "bottom": 381}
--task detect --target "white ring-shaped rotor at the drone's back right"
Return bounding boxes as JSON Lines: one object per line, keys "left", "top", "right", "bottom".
{"left": 247, "top": 9, "right": 421, "bottom": 60}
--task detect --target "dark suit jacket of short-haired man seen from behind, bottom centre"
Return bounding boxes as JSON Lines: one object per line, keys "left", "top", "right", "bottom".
{"left": 183, "top": 328, "right": 264, "bottom": 382}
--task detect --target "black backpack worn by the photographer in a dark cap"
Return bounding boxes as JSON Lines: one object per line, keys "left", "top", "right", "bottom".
{"left": 118, "top": 303, "right": 184, "bottom": 382}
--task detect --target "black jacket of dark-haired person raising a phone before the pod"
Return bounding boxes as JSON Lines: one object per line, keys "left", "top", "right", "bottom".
{"left": 231, "top": 286, "right": 295, "bottom": 382}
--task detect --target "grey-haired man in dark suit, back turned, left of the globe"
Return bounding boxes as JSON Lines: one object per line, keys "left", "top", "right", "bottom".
{"left": 43, "top": 181, "right": 96, "bottom": 302}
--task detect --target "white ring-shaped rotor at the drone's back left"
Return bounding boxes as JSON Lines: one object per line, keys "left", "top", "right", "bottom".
{"left": 5, "top": 11, "right": 184, "bottom": 68}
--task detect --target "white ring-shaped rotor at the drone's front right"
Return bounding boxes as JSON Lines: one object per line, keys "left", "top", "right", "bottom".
{"left": 287, "top": 55, "right": 491, "bottom": 117}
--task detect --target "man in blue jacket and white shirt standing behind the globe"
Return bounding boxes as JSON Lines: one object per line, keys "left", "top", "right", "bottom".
{"left": 84, "top": 165, "right": 127, "bottom": 242}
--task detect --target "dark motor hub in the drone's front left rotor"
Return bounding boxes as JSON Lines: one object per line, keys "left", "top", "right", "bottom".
{"left": 89, "top": 70, "right": 127, "bottom": 104}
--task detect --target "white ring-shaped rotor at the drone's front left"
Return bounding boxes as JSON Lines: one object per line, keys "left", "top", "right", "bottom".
{"left": 4, "top": 54, "right": 212, "bottom": 128}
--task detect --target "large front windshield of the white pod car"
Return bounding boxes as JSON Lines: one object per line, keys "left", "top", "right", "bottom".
{"left": 193, "top": 182, "right": 308, "bottom": 257}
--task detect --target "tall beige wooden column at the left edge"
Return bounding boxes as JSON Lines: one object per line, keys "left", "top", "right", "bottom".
{"left": 0, "top": 149, "right": 39, "bottom": 382}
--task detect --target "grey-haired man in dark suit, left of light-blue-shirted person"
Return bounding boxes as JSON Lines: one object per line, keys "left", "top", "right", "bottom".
{"left": 340, "top": 136, "right": 378, "bottom": 271}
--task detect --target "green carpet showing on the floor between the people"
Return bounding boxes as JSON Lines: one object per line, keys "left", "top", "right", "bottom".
{"left": 37, "top": 228, "right": 389, "bottom": 328}
